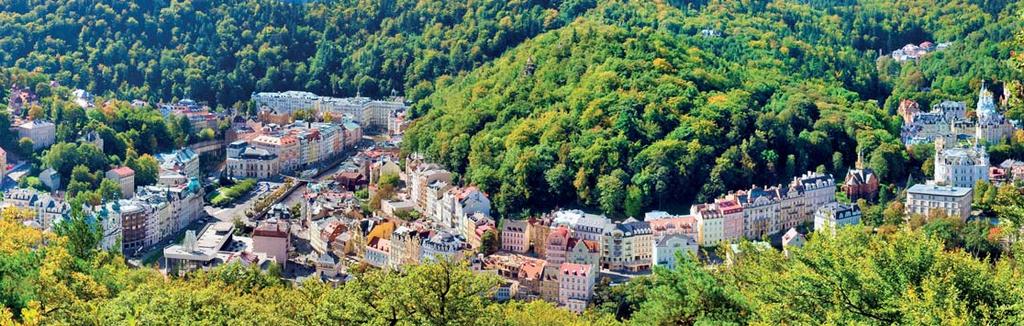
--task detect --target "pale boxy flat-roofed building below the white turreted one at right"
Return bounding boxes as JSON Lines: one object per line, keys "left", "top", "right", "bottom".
{"left": 905, "top": 184, "right": 974, "bottom": 220}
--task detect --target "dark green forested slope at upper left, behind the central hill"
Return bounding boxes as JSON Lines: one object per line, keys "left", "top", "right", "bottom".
{"left": 0, "top": 0, "right": 594, "bottom": 107}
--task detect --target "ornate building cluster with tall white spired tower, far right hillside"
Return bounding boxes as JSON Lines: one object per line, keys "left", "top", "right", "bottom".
{"left": 897, "top": 84, "right": 1017, "bottom": 146}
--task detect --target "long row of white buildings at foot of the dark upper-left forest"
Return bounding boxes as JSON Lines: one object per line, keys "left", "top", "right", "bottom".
{"left": 252, "top": 90, "right": 408, "bottom": 129}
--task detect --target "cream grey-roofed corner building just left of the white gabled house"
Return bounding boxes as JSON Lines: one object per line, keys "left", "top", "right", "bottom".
{"left": 602, "top": 217, "right": 652, "bottom": 272}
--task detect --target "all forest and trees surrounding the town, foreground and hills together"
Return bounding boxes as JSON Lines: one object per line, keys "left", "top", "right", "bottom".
{"left": 0, "top": 0, "right": 1024, "bottom": 325}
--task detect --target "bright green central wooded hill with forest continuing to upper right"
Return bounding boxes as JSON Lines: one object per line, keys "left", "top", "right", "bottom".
{"left": 404, "top": 0, "right": 1020, "bottom": 216}
